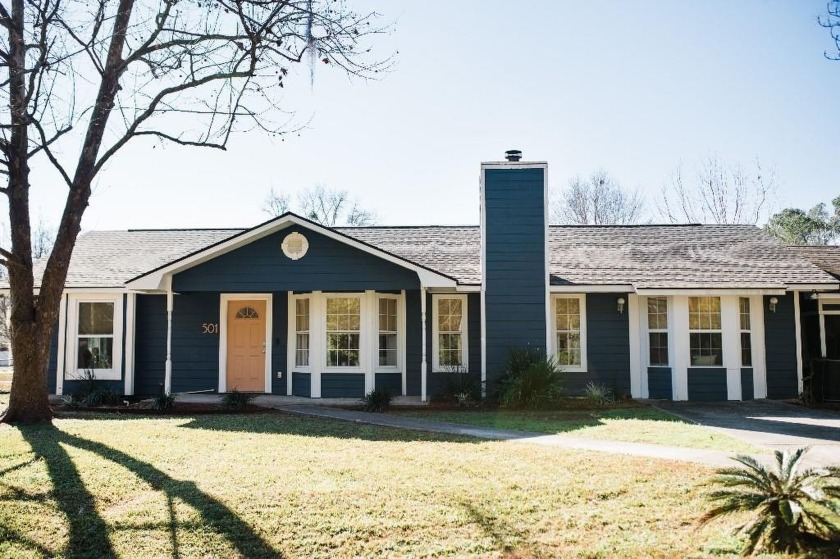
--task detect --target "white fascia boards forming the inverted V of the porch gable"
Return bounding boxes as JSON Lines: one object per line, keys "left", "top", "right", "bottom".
{"left": 126, "top": 215, "right": 457, "bottom": 291}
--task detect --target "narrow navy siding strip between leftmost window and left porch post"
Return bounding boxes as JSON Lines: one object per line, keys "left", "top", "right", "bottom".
{"left": 134, "top": 295, "right": 166, "bottom": 396}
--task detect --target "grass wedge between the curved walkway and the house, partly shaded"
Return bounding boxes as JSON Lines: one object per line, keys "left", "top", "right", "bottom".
{"left": 393, "top": 404, "right": 767, "bottom": 453}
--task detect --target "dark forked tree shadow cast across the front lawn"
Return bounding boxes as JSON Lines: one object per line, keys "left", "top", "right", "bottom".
{"left": 20, "top": 426, "right": 282, "bottom": 557}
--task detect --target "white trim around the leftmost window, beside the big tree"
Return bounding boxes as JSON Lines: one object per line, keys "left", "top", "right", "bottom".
{"left": 62, "top": 293, "right": 124, "bottom": 380}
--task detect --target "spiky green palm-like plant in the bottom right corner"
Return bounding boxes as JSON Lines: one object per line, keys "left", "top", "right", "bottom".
{"left": 701, "top": 448, "right": 840, "bottom": 555}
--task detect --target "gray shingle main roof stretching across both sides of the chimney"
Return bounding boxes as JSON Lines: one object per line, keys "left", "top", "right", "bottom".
{"left": 23, "top": 225, "right": 837, "bottom": 289}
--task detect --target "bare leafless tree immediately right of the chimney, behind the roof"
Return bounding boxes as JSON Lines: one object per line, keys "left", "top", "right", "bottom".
{"left": 551, "top": 170, "right": 645, "bottom": 225}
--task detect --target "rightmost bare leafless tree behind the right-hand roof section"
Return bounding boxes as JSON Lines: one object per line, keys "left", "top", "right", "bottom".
{"left": 657, "top": 155, "right": 776, "bottom": 225}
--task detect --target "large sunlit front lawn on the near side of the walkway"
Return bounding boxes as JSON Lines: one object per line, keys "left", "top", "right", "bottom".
{"left": 0, "top": 406, "right": 768, "bottom": 558}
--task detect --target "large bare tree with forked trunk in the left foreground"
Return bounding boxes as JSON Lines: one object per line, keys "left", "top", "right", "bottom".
{"left": 0, "top": 0, "right": 390, "bottom": 422}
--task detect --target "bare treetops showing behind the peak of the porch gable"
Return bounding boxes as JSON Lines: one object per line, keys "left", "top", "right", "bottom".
{"left": 263, "top": 184, "right": 376, "bottom": 227}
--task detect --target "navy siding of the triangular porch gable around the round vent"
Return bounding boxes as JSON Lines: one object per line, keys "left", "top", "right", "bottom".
{"left": 172, "top": 226, "right": 420, "bottom": 293}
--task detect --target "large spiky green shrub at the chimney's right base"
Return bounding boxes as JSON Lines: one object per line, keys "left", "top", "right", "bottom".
{"left": 491, "top": 346, "right": 563, "bottom": 408}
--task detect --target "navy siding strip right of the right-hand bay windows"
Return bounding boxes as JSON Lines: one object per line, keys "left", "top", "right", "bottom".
{"left": 764, "top": 293, "right": 799, "bottom": 398}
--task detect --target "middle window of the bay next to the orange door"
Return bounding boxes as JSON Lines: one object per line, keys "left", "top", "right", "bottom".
{"left": 327, "top": 297, "right": 362, "bottom": 367}
